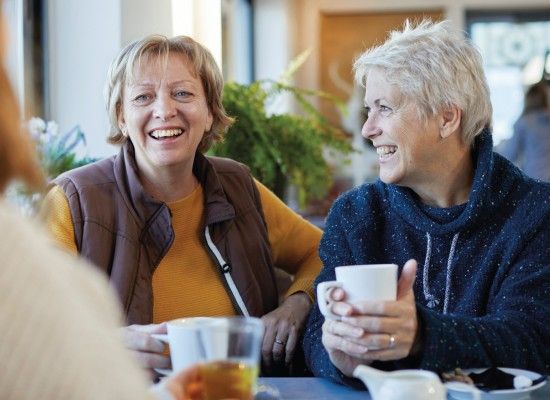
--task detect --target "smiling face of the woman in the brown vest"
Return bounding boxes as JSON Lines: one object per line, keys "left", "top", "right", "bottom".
{"left": 118, "top": 54, "right": 212, "bottom": 178}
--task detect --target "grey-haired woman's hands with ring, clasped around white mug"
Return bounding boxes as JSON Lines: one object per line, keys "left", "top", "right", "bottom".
{"left": 322, "top": 260, "right": 418, "bottom": 376}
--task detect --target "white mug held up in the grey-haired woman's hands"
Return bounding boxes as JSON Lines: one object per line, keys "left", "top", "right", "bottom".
{"left": 317, "top": 264, "right": 397, "bottom": 319}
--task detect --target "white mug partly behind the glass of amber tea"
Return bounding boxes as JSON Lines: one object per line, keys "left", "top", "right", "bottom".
{"left": 151, "top": 317, "right": 216, "bottom": 375}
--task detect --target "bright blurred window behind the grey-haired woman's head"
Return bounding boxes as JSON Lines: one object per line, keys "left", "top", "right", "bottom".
{"left": 466, "top": 9, "right": 550, "bottom": 145}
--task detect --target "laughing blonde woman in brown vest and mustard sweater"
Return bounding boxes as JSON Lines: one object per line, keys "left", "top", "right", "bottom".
{"left": 45, "top": 35, "right": 321, "bottom": 373}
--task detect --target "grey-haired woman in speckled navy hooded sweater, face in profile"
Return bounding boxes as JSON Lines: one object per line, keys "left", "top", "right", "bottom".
{"left": 304, "top": 21, "right": 550, "bottom": 385}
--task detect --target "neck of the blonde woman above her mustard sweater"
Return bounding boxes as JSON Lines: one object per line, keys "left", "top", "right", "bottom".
{"left": 139, "top": 165, "right": 199, "bottom": 203}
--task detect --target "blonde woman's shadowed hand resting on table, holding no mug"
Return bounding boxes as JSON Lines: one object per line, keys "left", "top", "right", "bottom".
{"left": 262, "top": 292, "right": 311, "bottom": 368}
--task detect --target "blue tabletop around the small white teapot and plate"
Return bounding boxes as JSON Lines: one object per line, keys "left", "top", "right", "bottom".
{"left": 259, "top": 378, "right": 550, "bottom": 400}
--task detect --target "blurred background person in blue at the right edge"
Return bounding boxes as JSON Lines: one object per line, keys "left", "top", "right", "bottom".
{"left": 502, "top": 82, "right": 550, "bottom": 182}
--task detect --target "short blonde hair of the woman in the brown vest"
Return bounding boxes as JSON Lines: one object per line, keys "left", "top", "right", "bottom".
{"left": 105, "top": 35, "right": 233, "bottom": 152}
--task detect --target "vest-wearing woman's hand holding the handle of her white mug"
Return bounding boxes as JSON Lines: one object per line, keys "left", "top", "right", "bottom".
{"left": 123, "top": 323, "right": 170, "bottom": 369}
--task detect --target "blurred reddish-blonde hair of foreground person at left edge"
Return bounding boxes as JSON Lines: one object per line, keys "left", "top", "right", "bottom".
{"left": 0, "top": 65, "right": 45, "bottom": 192}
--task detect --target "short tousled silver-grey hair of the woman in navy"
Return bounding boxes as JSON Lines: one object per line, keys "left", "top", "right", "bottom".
{"left": 353, "top": 20, "right": 493, "bottom": 145}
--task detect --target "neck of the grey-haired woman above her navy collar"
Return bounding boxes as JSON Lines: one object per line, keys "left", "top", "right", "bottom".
{"left": 412, "top": 138, "right": 474, "bottom": 208}
